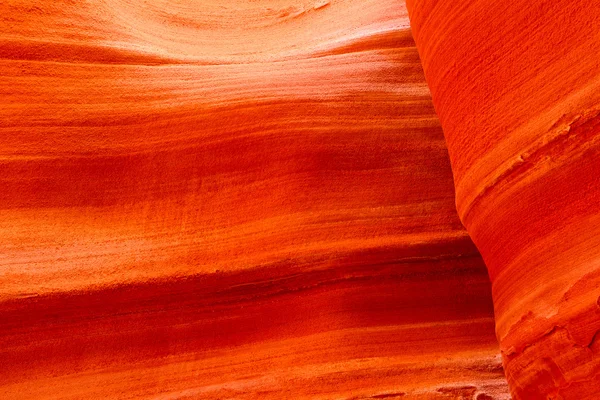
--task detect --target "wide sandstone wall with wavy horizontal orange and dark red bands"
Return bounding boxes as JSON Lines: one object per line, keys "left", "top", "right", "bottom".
{"left": 0, "top": 0, "right": 509, "bottom": 400}
